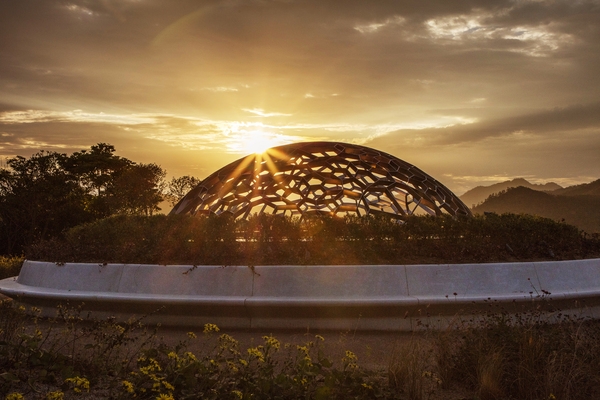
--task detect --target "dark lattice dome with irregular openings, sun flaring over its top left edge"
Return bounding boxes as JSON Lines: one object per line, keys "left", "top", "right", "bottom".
{"left": 171, "top": 142, "right": 471, "bottom": 219}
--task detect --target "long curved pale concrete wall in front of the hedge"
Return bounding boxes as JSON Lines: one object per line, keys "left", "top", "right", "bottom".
{"left": 0, "top": 259, "right": 600, "bottom": 330}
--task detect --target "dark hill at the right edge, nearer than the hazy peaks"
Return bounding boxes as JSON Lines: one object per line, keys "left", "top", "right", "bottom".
{"left": 472, "top": 187, "right": 600, "bottom": 233}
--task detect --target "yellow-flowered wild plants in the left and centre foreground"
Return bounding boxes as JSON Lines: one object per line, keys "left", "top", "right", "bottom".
{"left": 0, "top": 302, "right": 398, "bottom": 399}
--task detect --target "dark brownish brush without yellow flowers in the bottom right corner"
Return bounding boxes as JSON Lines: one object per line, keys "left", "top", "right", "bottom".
{"left": 434, "top": 306, "right": 600, "bottom": 400}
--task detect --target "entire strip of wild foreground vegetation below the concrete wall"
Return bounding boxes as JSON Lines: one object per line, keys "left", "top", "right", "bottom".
{"left": 0, "top": 301, "right": 600, "bottom": 400}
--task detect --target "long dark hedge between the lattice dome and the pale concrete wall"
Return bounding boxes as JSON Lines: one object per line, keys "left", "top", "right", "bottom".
{"left": 26, "top": 214, "right": 600, "bottom": 265}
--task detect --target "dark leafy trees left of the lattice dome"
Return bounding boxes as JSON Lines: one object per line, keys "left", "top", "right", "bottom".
{"left": 0, "top": 143, "right": 165, "bottom": 254}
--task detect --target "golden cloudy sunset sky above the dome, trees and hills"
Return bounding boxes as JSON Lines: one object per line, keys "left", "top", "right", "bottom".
{"left": 0, "top": 0, "right": 600, "bottom": 195}
